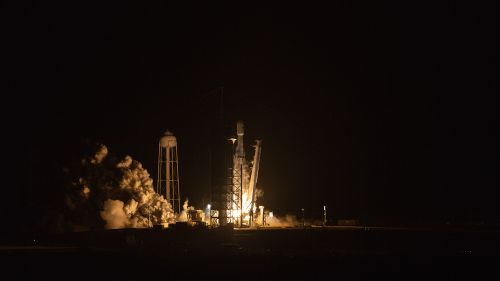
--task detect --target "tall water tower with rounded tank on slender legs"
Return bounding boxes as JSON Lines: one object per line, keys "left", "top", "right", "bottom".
{"left": 156, "top": 131, "right": 181, "bottom": 214}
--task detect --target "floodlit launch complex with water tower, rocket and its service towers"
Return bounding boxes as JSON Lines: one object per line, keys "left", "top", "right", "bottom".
{"left": 156, "top": 120, "right": 266, "bottom": 228}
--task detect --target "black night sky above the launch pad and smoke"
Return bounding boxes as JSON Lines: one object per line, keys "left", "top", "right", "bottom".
{"left": 2, "top": 1, "right": 500, "bottom": 231}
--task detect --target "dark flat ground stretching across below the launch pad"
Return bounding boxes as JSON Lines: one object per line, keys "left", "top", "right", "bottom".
{"left": 0, "top": 227, "right": 500, "bottom": 280}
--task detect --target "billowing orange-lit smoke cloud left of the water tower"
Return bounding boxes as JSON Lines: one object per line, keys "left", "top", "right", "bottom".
{"left": 65, "top": 144, "right": 175, "bottom": 229}
